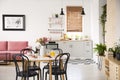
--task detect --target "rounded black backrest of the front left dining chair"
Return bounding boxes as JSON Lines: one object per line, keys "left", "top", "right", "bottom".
{"left": 12, "top": 54, "right": 29, "bottom": 74}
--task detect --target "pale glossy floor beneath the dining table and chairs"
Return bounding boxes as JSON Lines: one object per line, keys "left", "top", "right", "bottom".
{"left": 0, "top": 63, "right": 105, "bottom": 80}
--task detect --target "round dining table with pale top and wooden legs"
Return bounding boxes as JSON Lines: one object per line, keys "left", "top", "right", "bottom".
{"left": 25, "top": 54, "right": 55, "bottom": 80}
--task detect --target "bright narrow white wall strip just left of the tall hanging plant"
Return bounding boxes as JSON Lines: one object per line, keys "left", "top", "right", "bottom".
{"left": 91, "top": 0, "right": 100, "bottom": 43}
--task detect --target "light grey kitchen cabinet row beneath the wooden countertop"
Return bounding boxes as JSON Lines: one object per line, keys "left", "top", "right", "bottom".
{"left": 57, "top": 40, "right": 93, "bottom": 59}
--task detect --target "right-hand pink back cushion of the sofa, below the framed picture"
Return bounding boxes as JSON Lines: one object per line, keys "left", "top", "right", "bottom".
{"left": 8, "top": 41, "right": 28, "bottom": 51}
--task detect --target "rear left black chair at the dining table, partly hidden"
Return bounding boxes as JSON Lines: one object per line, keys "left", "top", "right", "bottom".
{"left": 20, "top": 48, "right": 41, "bottom": 78}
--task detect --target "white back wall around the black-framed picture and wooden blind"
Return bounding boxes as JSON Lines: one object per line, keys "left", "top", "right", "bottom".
{"left": 0, "top": 0, "right": 91, "bottom": 45}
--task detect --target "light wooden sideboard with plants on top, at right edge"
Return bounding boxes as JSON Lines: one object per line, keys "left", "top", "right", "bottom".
{"left": 104, "top": 56, "right": 120, "bottom": 80}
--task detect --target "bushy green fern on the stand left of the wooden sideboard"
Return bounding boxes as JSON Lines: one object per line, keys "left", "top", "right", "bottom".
{"left": 94, "top": 43, "right": 107, "bottom": 56}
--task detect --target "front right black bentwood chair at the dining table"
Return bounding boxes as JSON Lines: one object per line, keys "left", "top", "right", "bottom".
{"left": 45, "top": 53, "right": 70, "bottom": 80}
